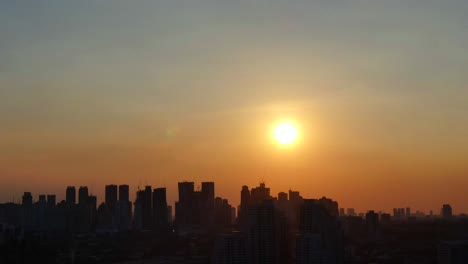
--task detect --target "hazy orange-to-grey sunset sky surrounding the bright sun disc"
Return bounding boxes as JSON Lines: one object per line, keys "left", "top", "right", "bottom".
{"left": 0, "top": 0, "right": 468, "bottom": 213}
